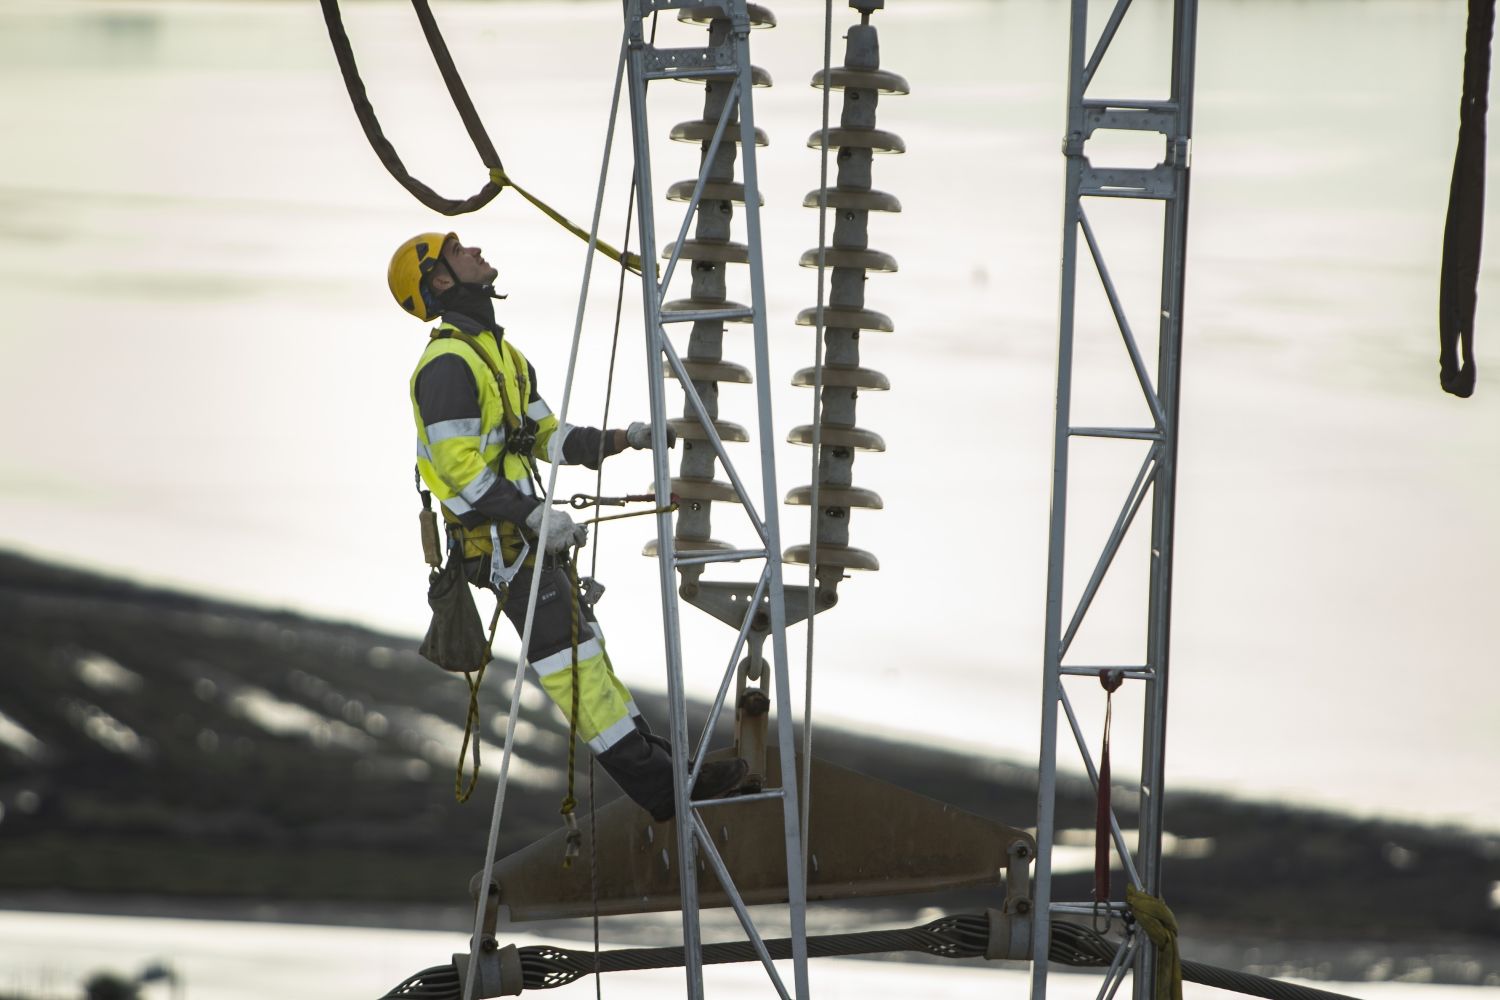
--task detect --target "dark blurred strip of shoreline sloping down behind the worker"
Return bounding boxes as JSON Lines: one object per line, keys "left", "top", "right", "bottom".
{"left": 0, "top": 553, "right": 1500, "bottom": 985}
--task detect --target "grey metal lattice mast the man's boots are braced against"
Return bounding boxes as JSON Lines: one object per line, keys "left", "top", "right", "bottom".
{"left": 626, "top": 0, "right": 807, "bottom": 1000}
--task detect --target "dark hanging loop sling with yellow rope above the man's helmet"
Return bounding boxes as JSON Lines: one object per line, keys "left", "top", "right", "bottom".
{"left": 320, "top": 0, "right": 641, "bottom": 273}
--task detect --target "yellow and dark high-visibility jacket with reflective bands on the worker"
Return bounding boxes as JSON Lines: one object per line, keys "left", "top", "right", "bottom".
{"left": 410, "top": 313, "right": 603, "bottom": 562}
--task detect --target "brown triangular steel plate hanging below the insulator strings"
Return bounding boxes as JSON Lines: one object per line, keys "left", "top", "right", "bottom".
{"left": 494, "top": 751, "right": 1037, "bottom": 925}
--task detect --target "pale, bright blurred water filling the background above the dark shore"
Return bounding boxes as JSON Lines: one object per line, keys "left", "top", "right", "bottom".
{"left": 0, "top": 0, "right": 1500, "bottom": 997}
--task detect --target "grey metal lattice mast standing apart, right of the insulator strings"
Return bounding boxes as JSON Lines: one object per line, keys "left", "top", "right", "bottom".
{"left": 1031, "top": 0, "right": 1197, "bottom": 1000}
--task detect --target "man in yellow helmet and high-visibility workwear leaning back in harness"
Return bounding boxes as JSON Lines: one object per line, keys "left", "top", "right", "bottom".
{"left": 387, "top": 232, "right": 749, "bottom": 822}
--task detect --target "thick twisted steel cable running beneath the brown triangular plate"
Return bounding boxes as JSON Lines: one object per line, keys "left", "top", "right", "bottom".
{"left": 383, "top": 913, "right": 1374, "bottom": 1000}
